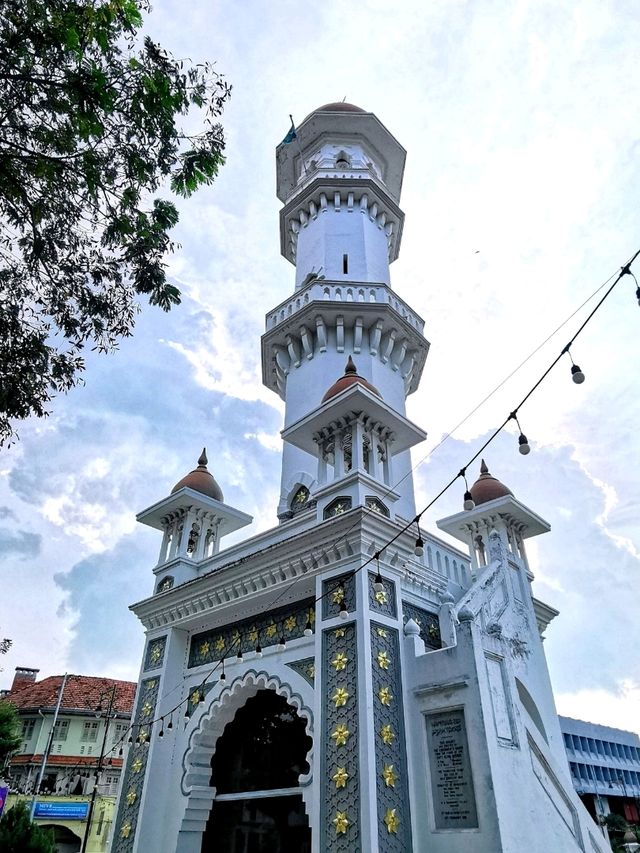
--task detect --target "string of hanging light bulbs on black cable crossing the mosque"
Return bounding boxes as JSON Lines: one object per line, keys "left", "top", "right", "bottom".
{"left": 96, "top": 249, "right": 640, "bottom": 740}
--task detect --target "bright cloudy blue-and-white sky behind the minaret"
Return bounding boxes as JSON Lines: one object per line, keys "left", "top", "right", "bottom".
{"left": 0, "top": 0, "right": 640, "bottom": 731}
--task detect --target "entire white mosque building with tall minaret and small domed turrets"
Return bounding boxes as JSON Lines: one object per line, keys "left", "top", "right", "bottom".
{"left": 112, "top": 103, "right": 609, "bottom": 853}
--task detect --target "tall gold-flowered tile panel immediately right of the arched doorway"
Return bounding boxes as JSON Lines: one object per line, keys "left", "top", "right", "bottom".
{"left": 319, "top": 622, "right": 362, "bottom": 853}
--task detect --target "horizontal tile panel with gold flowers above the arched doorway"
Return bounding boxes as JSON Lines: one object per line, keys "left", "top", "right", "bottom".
{"left": 188, "top": 598, "right": 316, "bottom": 667}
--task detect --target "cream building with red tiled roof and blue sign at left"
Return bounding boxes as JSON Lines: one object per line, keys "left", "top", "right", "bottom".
{"left": 2, "top": 667, "right": 136, "bottom": 853}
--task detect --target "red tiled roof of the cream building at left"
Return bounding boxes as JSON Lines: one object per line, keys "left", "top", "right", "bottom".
{"left": 3, "top": 675, "right": 137, "bottom": 714}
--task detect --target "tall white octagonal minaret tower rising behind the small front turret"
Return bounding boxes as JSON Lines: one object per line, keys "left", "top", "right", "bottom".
{"left": 262, "top": 103, "right": 429, "bottom": 520}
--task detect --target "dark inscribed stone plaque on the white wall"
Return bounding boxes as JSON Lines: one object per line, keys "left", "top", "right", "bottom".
{"left": 427, "top": 709, "right": 478, "bottom": 829}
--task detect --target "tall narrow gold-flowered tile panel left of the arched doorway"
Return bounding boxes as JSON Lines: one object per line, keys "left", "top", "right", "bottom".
{"left": 111, "top": 676, "right": 164, "bottom": 853}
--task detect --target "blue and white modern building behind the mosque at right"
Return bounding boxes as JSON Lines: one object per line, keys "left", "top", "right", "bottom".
{"left": 559, "top": 717, "right": 640, "bottom": 824}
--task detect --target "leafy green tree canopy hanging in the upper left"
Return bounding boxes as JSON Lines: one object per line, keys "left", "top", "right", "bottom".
{"left": 0, "top": 0, "right": 230, "bottom": 444}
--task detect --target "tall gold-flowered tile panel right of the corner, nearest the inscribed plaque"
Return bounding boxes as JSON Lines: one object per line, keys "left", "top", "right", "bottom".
{"left": 371, "top": 622, "right": 412, "bottom": 853}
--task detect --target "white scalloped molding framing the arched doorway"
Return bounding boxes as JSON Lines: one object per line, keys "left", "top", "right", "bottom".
{"left": 180, "top": 669, "right": 314, "bottom": 849}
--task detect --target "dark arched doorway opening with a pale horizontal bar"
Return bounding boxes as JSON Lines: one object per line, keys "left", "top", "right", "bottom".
{"left": 202, "top": 690, "right": 311, "bottom": 853}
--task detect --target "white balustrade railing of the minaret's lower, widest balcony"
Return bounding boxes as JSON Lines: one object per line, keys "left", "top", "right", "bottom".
{"left": 265, "top": 278, "right": 424, "bottom": 332}
